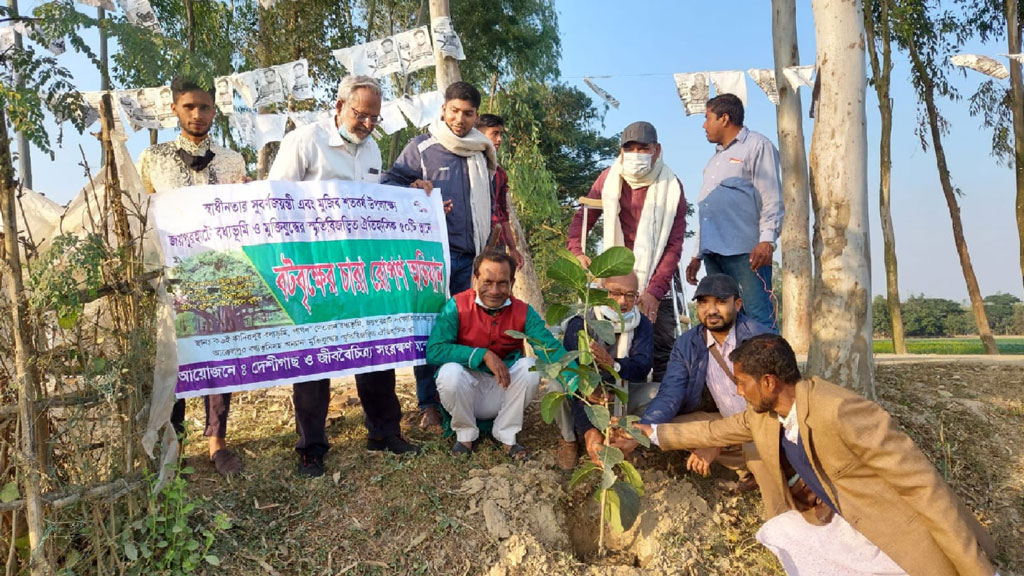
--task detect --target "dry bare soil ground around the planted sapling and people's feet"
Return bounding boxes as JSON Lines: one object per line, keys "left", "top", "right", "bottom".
{"left": 176, "top": 361, "right": 1024, "bottom": 576}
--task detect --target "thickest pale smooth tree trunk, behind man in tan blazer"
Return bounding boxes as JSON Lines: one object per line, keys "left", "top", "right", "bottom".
{"left": 807, "top": 0, "right": 874, "bottom": 398}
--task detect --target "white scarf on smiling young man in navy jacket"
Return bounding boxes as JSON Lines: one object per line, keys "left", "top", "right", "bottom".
{"left": 427, "top": 117, "right": 498, "bottom": 254}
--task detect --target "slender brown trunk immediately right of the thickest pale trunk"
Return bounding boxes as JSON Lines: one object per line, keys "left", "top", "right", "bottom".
{"left": 864, "top": 0, "right": 906, "bottom": 354}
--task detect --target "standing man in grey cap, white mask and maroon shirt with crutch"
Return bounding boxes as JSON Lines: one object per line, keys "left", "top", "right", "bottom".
{"left": 566, "top": 122, "right": 686, "bottom": 381}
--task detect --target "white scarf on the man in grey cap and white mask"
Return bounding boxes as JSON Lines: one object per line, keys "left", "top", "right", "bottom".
{"left": 601, "top": 155, "right": 683, "bottom": 292}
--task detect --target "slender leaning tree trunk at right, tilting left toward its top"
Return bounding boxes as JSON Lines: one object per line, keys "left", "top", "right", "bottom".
{"left": 907, "top": 38, "right": 999, "bottom": 355}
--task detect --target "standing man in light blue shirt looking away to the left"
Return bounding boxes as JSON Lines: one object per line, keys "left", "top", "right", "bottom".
{"left": 686, "top": 94, "right": 785, "bottom": 331}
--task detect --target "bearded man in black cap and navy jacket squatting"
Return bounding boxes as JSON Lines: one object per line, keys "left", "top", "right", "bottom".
{"left": 614, "top": 274, "right": 783, "bottom": 518}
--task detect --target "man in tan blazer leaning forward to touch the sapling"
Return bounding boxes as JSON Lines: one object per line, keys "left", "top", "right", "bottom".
{"left": 641, "top": 334, "right": 995, "bottom": 576}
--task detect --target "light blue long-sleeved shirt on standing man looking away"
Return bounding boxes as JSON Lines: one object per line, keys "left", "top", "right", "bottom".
{"left": 695, "top": 127, "right": 785, "bottom": 258}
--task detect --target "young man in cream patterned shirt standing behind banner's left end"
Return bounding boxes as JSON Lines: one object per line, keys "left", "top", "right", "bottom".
{"left": 138, "top": 78, "right": 246, "bottom": 476}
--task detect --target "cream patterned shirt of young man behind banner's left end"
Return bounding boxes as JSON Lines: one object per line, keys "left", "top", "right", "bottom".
{"left": 138, "top": 134, "right": 246, "bottom": 194}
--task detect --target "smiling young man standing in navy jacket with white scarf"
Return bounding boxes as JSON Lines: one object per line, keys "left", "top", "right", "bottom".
{"left": 381, "top": 82, "right": 498, "bottom": 431}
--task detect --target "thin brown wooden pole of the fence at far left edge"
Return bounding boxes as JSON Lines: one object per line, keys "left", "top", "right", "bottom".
{"left": 0, "top": 107, "right": 53, "bottom": 576}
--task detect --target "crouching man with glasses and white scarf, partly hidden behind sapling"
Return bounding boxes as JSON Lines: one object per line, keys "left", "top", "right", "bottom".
{"left": 555, "top": 273, "right": 657, "bottom": 469}
